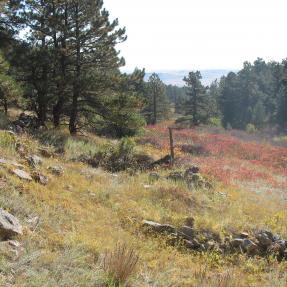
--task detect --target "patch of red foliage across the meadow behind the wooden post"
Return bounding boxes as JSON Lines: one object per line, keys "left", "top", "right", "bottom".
{"left": 147, "top": 124, "right": 287, "bottom": 191}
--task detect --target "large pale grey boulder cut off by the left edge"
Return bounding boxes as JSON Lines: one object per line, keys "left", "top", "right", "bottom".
{"left": 0, "top": 208, "right": 23, "bottom": 239}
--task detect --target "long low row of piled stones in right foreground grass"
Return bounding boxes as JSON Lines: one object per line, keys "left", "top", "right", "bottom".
{"left": 142, "top": 218, "right": 287, "bottom": 260}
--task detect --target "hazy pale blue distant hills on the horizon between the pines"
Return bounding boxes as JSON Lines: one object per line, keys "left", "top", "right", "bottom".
{"left": 145, "top": 69, "right": 236, "bottom": 86}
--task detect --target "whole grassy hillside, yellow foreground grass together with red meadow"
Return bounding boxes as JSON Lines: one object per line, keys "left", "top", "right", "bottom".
{"left": 0, "top": 124, "right": 287, "bottom": 287}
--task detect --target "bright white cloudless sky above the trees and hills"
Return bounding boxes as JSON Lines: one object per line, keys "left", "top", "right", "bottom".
{"left": 104, "top": 0, "right": 287, "bottom": 71}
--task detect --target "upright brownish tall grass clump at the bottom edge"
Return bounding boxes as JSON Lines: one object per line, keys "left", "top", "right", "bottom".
{"left": 102, "top": 244, "right": 139, "bottom": 287}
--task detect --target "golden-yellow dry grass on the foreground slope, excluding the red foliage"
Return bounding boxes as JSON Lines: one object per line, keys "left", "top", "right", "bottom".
{"left": 0, "top": 124, "right": 287, "bottom": 287}
